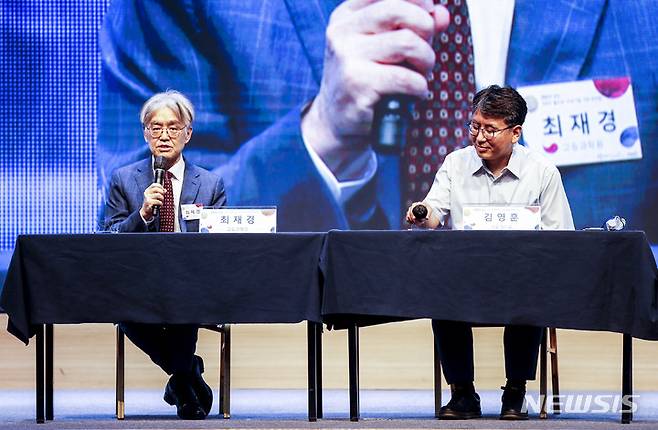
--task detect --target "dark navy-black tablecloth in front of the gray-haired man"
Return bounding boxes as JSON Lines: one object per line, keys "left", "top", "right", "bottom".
{"left": 0, "top": 233, "right": 325, "bottom": 343}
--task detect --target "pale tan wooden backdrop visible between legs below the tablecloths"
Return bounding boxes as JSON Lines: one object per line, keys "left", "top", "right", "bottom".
{"left": 0, "top": 315, "right": 658, "bottom": 392}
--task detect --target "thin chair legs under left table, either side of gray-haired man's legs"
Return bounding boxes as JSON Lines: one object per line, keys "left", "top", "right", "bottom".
{"left": 116, "top": 324, "right": 231, "bottom": 420}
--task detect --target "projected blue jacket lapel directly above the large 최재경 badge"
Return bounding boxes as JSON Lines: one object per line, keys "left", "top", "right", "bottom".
{"left": 506, "top": 0, "right": 606, "bottom": 87}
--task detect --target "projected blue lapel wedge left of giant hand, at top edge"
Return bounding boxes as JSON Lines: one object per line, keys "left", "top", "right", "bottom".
{"left": 286, "top": 0, "right": 340, "bottom": 85}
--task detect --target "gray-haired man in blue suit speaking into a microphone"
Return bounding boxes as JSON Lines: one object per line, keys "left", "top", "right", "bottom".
{"left": 105, "top": 90, "right": 226, "bottom": 419}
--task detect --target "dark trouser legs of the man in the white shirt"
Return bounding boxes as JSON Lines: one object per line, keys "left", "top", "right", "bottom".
{"left": 432, "top": 320, "right": 543, "bottom": 384}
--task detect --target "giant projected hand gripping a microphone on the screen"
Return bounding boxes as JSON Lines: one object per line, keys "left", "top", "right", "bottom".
{"left": 302, "top": 0, "right": 450, "bottom": 173}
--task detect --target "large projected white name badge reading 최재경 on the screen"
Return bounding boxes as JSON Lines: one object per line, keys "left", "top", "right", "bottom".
{"left": 518, "top": 78, "right": 642, "bottom": 166}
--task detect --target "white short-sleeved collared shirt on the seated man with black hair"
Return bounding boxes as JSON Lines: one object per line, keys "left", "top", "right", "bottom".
{"left": 424, "top": 144, "right": 574, "bottom": 230}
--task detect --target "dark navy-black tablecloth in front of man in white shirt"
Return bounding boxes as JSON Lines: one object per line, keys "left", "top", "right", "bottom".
{"left": 322, "top": 231, "right": 658, "bottom": 340}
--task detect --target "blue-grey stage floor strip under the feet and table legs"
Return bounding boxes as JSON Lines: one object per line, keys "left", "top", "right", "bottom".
{"left": 0, "top": 389, "right": 658, "bottom": 429}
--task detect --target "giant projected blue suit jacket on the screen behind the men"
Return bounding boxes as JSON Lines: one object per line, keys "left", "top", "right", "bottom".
{"left": 98, "top": 0, "right": 658, "bottom": 241}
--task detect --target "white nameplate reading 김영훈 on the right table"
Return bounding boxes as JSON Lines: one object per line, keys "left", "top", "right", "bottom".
{"left": 463, "top": 205, "right": 541, "bottom": 230}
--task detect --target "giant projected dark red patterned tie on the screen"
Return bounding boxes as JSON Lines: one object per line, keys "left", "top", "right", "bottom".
{"left": 400, "top": 0, "right": 475, "bottom": 214}
